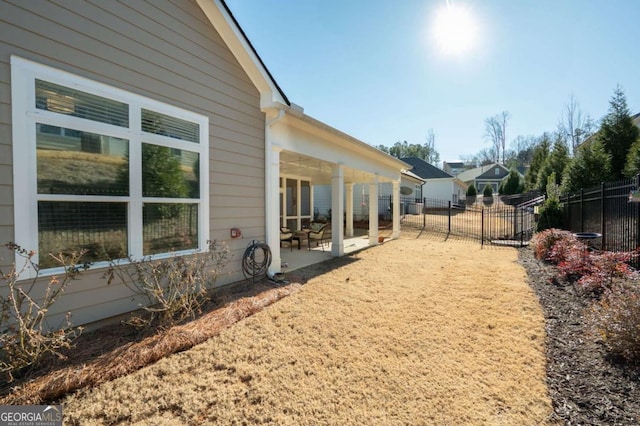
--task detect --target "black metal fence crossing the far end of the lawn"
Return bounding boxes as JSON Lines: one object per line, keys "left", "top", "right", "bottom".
{"left": 378, "top": 196, "right": 534, "bottom": 245}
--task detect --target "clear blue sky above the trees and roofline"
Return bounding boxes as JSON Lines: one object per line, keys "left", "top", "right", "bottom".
{"left": 226, "top": 0, "right": 640, "bottom": 161}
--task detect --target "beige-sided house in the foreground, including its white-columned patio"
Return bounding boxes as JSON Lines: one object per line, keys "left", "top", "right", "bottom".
{"left": 0, "top": 0, "right": 409, "bottom": 325}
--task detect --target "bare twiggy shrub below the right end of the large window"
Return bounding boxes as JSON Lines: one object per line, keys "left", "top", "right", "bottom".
{"left": 105, "top": 241, "right": 229, "bottom": 327}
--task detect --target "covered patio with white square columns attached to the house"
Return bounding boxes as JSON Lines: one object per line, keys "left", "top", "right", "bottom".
{"left": 265, "top": 104, "right": 411, "bottom": 273}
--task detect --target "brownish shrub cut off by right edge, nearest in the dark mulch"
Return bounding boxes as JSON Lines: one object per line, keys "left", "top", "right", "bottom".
{"left": 586, "top": 283, "right": 640, "bottom": 362}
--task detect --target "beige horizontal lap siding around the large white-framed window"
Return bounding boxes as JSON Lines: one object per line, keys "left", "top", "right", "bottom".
{"left": 0, "top": 0, "right": 265, "bottom": 323}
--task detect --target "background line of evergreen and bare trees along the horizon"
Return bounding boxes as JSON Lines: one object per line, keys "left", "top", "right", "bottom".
{"left": 377, "top": 85, "right": 640, "bottom": 200}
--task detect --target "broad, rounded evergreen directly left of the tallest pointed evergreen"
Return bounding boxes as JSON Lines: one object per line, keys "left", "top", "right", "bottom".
{"left": 562, "top": 140, "right": 611, "bottom": 192}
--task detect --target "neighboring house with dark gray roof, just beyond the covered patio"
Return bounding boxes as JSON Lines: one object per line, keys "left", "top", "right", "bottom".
{"left": 401, "top": 157, "right": 467, "bottom": 203}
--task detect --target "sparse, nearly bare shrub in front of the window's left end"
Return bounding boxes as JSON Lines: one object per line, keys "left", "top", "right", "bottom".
{"left": 0, "top": 243, "right": 89, "bottom": 382}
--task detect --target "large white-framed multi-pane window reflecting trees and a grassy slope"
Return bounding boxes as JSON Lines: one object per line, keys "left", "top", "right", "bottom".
{"left": 11, "top": 57, "right": 208, "bottom": 273}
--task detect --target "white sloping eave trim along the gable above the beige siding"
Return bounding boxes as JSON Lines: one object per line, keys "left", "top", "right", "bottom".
{"left": 196, "top": 0, "right": 286, "bottom": 109}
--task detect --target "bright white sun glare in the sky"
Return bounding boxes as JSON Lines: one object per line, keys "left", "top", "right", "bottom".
{"left": 432, "top": 1, "right": 478, "bottom": 55}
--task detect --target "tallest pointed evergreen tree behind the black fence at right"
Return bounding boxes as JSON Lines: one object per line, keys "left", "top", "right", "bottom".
{"left": 598, "top": 85, "right": 640, "bottom": 179}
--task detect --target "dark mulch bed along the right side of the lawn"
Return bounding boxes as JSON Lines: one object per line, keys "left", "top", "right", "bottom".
{"left": 519, "top": 248, "right": 640, "bottom": 425}
